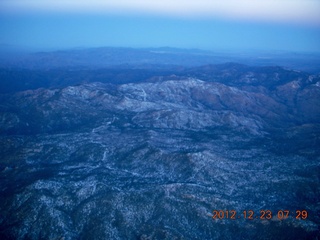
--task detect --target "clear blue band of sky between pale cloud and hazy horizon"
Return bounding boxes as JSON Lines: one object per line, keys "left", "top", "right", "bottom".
{"left": 0, "top": 12, "right": 320, "bottom": 52}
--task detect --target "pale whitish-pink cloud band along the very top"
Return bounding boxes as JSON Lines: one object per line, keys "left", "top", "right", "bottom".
{"left": 0, "top": 0, "right": 320, "bottom": 26}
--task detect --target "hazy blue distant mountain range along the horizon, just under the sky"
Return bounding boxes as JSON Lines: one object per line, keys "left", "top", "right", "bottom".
{"left": 0, "top": 47, "right": 320, "bottom": 73}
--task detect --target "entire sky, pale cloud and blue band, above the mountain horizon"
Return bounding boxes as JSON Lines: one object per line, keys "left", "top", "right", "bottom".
{"left": 0, "top": 0, "right": 320, "bottom": 52}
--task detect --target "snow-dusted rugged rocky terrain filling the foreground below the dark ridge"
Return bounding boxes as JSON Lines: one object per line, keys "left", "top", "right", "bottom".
{"left": 0, "top": 64, "right": 320, "bottom": 239}
